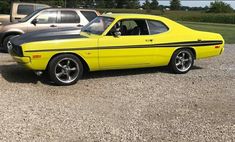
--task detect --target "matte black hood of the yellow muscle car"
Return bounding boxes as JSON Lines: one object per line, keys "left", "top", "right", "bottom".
{"left": 11, "top": 28, "right": 86, "bottom": 45}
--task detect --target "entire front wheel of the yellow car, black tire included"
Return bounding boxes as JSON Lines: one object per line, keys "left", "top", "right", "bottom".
{"left": 48, "top": 54, "right": 83, "bottom": 86}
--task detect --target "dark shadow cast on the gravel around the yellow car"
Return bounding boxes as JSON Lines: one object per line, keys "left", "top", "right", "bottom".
{"left": 0, "top": 64, "right": 202, "bottom": 85}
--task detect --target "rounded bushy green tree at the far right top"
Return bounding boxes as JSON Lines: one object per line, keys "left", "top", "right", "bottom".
{"left": 208, "top": 0, "right": 233, "bottom": 13}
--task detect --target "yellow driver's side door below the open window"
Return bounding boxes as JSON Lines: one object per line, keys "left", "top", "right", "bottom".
{"left": 99, "top": 35, "right": 155, "bottom": 69}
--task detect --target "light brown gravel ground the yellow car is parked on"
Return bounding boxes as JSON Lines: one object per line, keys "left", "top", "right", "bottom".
{"left": 0, "top": 45, "right": 235, "bottom": 142}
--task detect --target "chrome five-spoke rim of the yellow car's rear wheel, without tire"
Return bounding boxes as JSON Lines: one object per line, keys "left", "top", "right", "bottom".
{"left": 175, "top": 50, "right": 193, "bottom": 72}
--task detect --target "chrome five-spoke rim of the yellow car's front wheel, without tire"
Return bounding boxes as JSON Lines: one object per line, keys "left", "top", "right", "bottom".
{"left": 55, "top": 58, "right": 80, "bottom": 84}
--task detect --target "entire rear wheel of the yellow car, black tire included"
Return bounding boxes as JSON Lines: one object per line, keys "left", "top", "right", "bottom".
{"left": 170, "top": 49, "right": 194, "bottom": 74}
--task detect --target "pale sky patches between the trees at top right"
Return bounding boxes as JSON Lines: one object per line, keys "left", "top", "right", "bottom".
{"left": 140, "top": 0, "right": 235, "bottom": 9}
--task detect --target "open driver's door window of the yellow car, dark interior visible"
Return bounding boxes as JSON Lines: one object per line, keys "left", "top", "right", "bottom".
{"left": 107, "top": 19, "right": 149, "bottom": 36}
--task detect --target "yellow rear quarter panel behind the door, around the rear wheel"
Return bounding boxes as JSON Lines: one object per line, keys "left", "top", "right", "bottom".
{"left": 154, "top": 19, "right": 224, "bottom": 65}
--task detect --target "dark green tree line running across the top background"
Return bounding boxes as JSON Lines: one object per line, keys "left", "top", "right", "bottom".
{"left": 0, "top": 0, "right": 234, "bottom": 13}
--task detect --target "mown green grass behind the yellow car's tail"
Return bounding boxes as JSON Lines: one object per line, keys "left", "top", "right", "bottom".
{"left": 179, "top": 21, "right": 235, "bottom": 44}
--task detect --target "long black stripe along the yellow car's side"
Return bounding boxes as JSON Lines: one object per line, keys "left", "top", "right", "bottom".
{"left": 25, "top": 40, "right": 223, "bottom": 52}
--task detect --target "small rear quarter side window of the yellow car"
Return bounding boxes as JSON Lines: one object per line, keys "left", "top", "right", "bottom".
{"left": 148, "top": 20, "right": 169, "bottom": 35}
